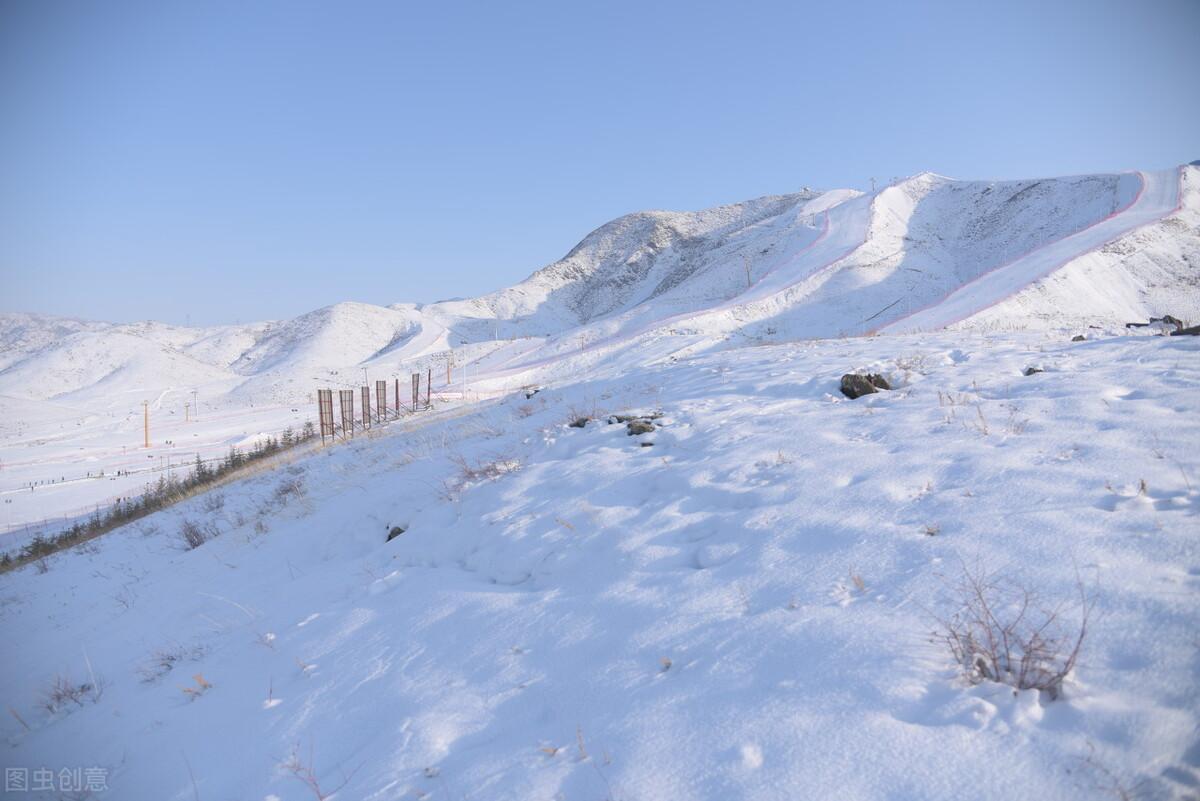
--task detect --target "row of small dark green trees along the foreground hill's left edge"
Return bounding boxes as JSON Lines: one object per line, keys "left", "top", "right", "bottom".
{"left": 0, "top": 421, "right": 317, "bottom": 572}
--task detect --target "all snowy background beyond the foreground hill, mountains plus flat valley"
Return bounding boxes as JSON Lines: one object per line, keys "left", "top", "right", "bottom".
{"left": 0, "top": 165, "right": 1200, "bottom": 530}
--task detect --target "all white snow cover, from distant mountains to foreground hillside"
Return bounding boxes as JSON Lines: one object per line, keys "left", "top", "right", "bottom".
{"left": 0, "top": 165, "right": 1200, "bottom": 801}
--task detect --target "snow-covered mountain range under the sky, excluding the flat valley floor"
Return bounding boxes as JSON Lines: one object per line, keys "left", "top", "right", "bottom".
{"left": 0, "top": 167, "right": 1200, "bottom": 402}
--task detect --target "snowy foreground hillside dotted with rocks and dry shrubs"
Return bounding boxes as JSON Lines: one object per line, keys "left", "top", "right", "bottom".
{"left": 0, "top": 333, "right": 1200, "bottom": 801}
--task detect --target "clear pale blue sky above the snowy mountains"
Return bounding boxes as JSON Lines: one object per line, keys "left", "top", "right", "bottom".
{"left": 0, "top": 0, "right": 1200, "bottom": 325}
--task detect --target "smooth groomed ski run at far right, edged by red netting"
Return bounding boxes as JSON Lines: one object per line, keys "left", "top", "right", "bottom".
{"left": 872, "top": 168, "right": 1183, "bottom": 333}
